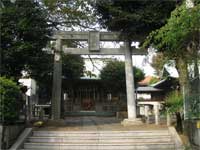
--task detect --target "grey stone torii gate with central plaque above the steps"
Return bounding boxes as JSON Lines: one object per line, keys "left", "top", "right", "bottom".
{"left": 51, "top": 31, "right": 146, "bottom": 123}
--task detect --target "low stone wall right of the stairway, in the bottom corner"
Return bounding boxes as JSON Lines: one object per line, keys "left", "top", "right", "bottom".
{"left": 184, "top": 120, "right": 200, "bottom": 149}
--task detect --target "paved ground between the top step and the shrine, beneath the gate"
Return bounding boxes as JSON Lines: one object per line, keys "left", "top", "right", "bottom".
{"left": 38, "top": 116, "right": 167, "bottom": 131}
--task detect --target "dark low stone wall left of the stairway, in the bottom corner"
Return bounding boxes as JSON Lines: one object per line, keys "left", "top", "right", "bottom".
{"left": 0, "top": 123, "right": 25, "bottom": 149}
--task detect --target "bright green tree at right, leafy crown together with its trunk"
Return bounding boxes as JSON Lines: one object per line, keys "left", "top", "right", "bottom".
{"left": 144, "top": 2, "right": 200, "bottom": 94}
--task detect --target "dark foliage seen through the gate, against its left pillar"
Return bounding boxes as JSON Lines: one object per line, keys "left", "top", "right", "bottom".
{"left": 62, "top": 55, "right": 85, "bottom": 79}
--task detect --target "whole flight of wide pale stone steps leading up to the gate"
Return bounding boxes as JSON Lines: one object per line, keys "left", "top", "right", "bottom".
{"left": 20, "top": 129, "right": 175, "bottom": 150}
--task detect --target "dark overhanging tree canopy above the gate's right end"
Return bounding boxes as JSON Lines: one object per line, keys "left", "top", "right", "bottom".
{"left": 95, "top": 0, "right": 178, "bottom": 40}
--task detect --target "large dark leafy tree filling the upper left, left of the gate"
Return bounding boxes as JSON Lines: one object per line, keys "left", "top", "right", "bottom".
{"left": 0, "top": 0, "right": 51, "bottom": 79}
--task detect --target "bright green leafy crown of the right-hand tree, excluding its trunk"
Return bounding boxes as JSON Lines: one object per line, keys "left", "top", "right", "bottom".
{"left": 143, "top": 4, "right": 200, "bottom": 59}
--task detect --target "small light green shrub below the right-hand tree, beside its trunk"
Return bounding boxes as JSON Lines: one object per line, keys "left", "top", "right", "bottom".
{"left": 165, "top": 91, "right": 183, "bottom": 113}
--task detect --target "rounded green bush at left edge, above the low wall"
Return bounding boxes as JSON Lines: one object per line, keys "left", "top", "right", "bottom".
{"left": 0, "top": 77, "right": 22, "bottom": 122}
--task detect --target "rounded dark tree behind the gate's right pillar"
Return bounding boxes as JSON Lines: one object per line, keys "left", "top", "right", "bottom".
{"left": 100, "top": 60, "right": 144, "bottom": 92}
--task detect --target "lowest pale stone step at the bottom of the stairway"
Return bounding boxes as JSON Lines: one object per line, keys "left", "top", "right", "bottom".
{"left": 24, "top": 143, "right": 174, "bottom": 150}
